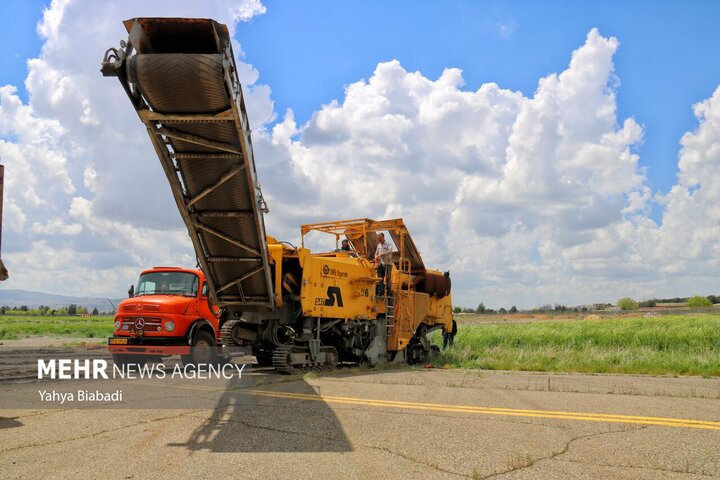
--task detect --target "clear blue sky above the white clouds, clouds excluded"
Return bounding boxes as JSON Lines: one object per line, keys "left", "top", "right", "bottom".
{"left": 0, "top": 0, "right": 720, "bottom": 213}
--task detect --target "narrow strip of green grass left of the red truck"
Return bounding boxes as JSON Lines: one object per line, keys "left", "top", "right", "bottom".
{"left": 0, "top": 315, "right": 113, "bottom": 340}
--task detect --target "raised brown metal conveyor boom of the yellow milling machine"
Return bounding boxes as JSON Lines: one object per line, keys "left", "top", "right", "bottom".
{"left": 102, "top": 18, "right": 274, "bottom": 311}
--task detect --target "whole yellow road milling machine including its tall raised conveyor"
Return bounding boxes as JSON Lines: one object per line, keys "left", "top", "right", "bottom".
{"left": 102, "top": 18, "right": 452, "bottom": 373}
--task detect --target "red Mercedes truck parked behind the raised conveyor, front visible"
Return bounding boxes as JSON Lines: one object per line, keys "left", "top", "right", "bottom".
{"left": 108, "top": 267, "right": 221, "bottom": 365}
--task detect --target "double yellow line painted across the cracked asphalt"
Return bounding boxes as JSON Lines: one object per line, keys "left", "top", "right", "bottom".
{"left": 247, "top": 390, "right": 720, "bottom": 430}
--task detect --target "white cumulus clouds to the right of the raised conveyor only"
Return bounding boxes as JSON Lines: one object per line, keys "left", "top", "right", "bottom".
{"left": 255, "top": 29, "right": 719, "bottom": 307}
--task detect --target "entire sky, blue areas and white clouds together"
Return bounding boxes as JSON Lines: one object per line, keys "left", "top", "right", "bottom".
{"left": 0, "top": 0, "right": 720, "bottom": 307}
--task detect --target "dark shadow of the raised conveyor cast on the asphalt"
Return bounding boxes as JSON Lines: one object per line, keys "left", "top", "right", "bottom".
{"left": 173, "top": 377, "right": 352, "bottom": 453}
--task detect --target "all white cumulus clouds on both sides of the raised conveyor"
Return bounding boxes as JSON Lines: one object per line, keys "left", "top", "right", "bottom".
{"left": 0, "top": 5, "right": 720, "bottom": 307}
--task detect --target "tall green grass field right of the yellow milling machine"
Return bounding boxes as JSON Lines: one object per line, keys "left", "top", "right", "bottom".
{"left": 433, "top": 314, "right": 720, "bottom": 376}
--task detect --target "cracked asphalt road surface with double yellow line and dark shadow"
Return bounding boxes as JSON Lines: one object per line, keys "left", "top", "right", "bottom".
{"left": 0, "top": 368, "right": 720, "bottom": 479}
